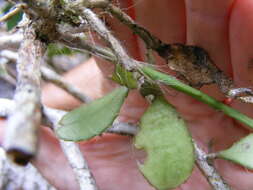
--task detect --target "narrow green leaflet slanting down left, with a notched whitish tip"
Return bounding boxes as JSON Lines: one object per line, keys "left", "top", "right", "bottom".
{"left": 56, "top": 87, "right": 128, "bottom": 141}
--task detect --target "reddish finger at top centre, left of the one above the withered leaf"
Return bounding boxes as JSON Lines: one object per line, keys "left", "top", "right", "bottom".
{"left": 134, "top": 0, "right": 186, "bottom": 54}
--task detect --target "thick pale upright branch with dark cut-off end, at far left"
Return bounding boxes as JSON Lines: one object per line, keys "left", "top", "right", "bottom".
{"left": 4, "top": 20, "right": 45, "bottom": 165}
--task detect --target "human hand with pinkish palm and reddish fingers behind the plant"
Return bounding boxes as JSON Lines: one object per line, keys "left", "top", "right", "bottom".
{"left": 2, "top": 0, "right": 253, "bottom": 190}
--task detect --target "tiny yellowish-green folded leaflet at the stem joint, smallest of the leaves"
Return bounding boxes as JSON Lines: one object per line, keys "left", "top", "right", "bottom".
{"left": 112, "top": 64, "right": 138, "bottom": 89}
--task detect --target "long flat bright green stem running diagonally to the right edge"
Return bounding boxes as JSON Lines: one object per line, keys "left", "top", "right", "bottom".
{"left": 140, "top": 66, "right": 253, "bottom": 128}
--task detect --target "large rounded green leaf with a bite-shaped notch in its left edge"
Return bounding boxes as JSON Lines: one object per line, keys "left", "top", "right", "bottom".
{"left": 135, "top": 97, "right": 194, "bottom": 190}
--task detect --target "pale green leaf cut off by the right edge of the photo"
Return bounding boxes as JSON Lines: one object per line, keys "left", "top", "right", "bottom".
{"left": 218, "top": 134, "right": 253, "bottom": 169}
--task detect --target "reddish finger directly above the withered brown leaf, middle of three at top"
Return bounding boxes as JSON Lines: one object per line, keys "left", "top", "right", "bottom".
{"left": 185, "top": 0, "right": 234, "bottom": 73}
